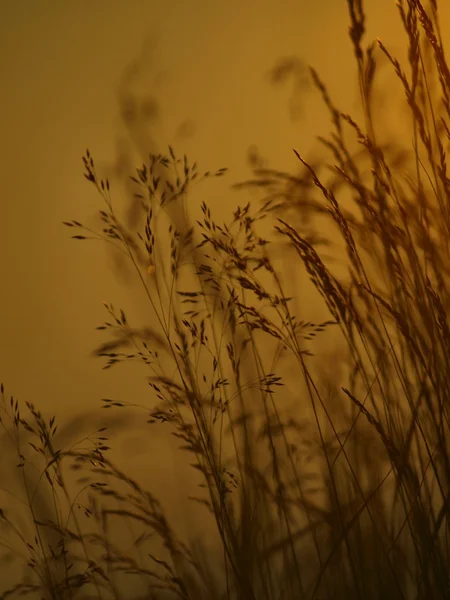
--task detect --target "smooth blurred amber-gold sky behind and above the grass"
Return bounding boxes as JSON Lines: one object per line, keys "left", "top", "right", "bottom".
{"left": 0, "top": 0, "right": 450, "bottom": 592}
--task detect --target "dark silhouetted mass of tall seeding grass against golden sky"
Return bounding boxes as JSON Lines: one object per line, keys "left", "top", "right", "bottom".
{"left": 0, "top": 0, "right": 450, "bottom": 600}
